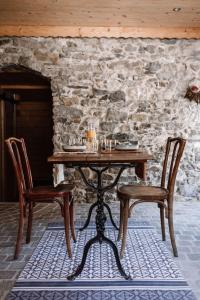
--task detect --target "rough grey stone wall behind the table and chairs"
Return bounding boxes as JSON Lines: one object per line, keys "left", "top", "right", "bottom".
{"left": 0, "top": 38, "right": 200, "bottom": 200}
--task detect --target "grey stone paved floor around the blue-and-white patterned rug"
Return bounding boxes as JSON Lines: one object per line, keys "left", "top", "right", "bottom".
{"left": 0, "top": 201, "right": 200, "bottom": 300}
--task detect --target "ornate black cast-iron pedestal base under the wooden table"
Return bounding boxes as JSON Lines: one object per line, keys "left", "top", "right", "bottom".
{"left": 67, "top": 163, "right": 135, "bottom": 280}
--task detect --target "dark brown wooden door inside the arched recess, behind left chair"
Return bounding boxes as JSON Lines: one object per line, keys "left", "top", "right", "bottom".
{"left": 16, "top": 89, "right": 53, "bottom": 185}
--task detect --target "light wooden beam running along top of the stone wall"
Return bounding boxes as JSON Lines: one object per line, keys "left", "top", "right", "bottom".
{"left": 0, "top": 25, "right": 200, "bottom": 39}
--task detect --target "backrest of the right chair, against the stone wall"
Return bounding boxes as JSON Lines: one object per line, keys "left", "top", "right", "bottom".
{"left": 161, "top": 137, "right": 186, "bottom": 195}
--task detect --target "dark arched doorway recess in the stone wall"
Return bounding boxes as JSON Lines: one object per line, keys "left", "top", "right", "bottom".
{"left": 0, "top": 65, "right": 53, "bottom": 202}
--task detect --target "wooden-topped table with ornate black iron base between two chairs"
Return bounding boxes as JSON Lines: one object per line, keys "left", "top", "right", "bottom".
{"left": 48, "top": 151, "right": 153, "bottom": 280}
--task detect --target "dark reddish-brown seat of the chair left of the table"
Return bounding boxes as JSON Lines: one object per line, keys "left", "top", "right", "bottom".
{"left": 25, "top": 184, "right": 74, "bottom": 199}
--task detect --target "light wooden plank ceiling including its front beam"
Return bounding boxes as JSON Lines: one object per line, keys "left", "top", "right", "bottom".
{"left": 0, "top": 0, "right": 200, "bottom": 38}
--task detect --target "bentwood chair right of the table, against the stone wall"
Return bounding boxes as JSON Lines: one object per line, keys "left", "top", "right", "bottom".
{"left": 117, "top": 137, "right": 186, "bottom": 257}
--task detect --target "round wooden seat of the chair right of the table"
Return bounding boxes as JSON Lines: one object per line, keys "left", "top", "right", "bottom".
{"left": 118, "top": 185, "right": 168, "bottom": 200}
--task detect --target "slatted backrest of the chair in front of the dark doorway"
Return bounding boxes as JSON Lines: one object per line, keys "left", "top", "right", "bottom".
{"left": 5, "top": 137, "right": 33, "bottom": 195}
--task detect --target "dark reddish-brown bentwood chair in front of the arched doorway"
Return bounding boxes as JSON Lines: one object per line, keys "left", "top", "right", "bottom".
{"left": 5, "top": 137, "right": 76, "bottom": 259}
